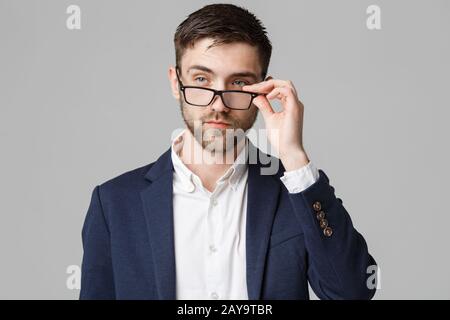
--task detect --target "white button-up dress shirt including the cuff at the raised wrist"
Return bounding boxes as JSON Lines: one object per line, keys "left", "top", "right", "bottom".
{"left": 171, "top": 130, "right": 319, "bottom": 300}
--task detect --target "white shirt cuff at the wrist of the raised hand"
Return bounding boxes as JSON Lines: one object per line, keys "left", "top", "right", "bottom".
{"left": 280, "top": 161, "right": 319, "bottom": 193}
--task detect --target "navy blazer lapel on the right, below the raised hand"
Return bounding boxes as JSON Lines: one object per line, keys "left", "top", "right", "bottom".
{"left": 246, "top": 144, "right": 280, "bottom": 300}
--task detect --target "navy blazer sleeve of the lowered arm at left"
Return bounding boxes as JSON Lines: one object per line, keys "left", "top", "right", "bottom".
{"left": 80, "top": 186, "right": 115, "bottom": 300}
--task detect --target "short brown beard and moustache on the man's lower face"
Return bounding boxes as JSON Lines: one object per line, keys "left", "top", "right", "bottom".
{"left": 180, "top": 100, "right": 258, "bottom": 154}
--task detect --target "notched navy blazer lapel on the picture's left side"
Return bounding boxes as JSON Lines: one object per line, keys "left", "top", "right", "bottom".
{"left": 141, "top": 149, "right": 176, "bottom": 300}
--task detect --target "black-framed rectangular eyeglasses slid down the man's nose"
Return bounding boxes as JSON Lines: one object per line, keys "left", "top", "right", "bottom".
{"left": 176, "top": 67, "right": 265, "bottom": 110}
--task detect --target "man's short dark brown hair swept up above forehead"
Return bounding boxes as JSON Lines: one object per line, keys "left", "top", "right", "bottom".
{"left": 174, "top": 4, "right": 272, "bottom": 79}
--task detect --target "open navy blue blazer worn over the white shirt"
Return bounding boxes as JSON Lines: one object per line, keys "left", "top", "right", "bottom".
{"left": 80, "top": 144, "right": 375, "bottom": 300}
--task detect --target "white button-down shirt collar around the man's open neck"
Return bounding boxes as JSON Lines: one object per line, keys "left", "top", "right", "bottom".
{"left": 171, "top": 129, "right": 249, "bottom": 192}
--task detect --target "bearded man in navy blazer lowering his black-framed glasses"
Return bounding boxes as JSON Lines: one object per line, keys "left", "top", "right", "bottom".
{"left": 80, "top": 4, "right": 375, "bottom": 300}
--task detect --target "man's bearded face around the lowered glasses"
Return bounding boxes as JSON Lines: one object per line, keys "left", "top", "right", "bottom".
{"left": 169, "top": 38, "right": 263, "bottom": 152}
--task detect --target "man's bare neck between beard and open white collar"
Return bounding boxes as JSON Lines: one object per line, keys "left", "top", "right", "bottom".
{"left": 180, "top": 130, "right": 245, "bottom": 191}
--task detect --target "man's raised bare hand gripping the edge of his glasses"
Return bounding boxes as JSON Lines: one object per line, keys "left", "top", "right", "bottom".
{"left": 242, "top": 79, "right": 309, "bottom": 171}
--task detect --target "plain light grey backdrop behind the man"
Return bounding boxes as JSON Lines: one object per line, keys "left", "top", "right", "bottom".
{"left": 0, "top": 0, "right": 450, "bottom": 299}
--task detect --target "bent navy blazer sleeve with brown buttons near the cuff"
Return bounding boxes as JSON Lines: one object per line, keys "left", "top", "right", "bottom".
{"left": 289, "top": 170, "right": 376, "bottom": 299}
